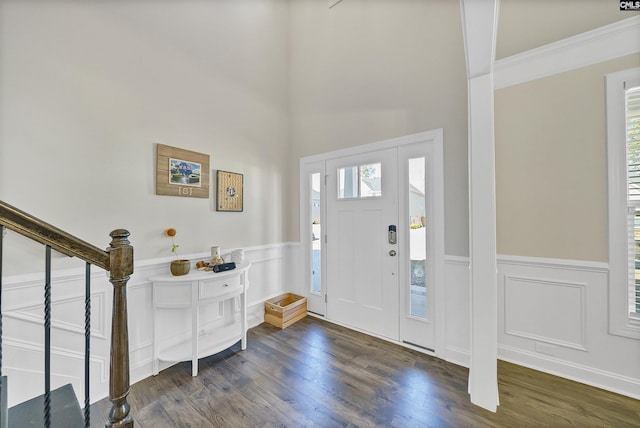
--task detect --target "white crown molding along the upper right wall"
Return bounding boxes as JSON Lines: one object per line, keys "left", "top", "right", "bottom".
{"left": 493, "top": 16, "right": 640, "bottom": 89}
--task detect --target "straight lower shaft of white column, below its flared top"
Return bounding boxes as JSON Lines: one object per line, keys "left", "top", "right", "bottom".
{"left": 469, "top": 75, "right": 498, "bottom": 412}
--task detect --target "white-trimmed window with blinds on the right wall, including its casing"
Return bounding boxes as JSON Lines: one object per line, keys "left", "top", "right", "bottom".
{"left": 605, "top": 67, "right": 640, "bottom": 340}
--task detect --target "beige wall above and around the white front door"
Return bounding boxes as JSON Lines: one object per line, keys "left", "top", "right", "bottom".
{"left": 289, "top": 0, "right": 469, "bottom": 256}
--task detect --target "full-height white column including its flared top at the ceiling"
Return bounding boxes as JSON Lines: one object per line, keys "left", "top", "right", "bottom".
{"left": 461, "top": 0, "right": 498, "bottom": 412}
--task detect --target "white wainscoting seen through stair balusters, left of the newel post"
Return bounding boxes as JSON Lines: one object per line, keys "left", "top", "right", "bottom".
{"left": 2, "top": 269, "right": 112, "bottom": 406}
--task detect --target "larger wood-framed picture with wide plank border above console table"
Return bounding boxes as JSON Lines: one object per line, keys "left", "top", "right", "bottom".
{"left": 156, "top": 144, "right": 209, "bottom": 199}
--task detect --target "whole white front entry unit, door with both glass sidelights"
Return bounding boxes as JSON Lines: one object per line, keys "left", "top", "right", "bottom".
{"left": 300, "top": 130, "right": 445, "bottom": 355}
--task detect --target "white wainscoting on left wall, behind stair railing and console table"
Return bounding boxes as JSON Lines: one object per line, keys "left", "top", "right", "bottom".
{"left": 2, "top": 243, "right": 297, "bottom": 406}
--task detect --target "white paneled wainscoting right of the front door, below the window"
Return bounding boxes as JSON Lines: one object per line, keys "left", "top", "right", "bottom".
{"left": 445, "top": 255, "right": 640, "bottom": 399}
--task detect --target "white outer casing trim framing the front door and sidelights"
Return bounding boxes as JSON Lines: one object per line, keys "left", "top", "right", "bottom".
{"left": 299, "top": 128, "right": 446, "bottom": 358}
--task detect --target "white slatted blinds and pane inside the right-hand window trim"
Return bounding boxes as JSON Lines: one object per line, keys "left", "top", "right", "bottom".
{"left": 625, "top": 86, "right": 640, "bottom": 314}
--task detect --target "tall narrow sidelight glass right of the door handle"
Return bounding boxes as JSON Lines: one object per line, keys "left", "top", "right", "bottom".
{"left": 407, "top": 157, "right": 427, "bottom": 318}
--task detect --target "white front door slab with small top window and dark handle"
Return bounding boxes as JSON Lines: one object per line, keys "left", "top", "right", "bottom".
{"left": 326, "top": 148, "right": 399, "bottom": 340}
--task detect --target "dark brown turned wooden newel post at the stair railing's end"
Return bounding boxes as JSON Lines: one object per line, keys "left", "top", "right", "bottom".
{"left": 106, "top": 229, "right": 133, "bottom": 428}
